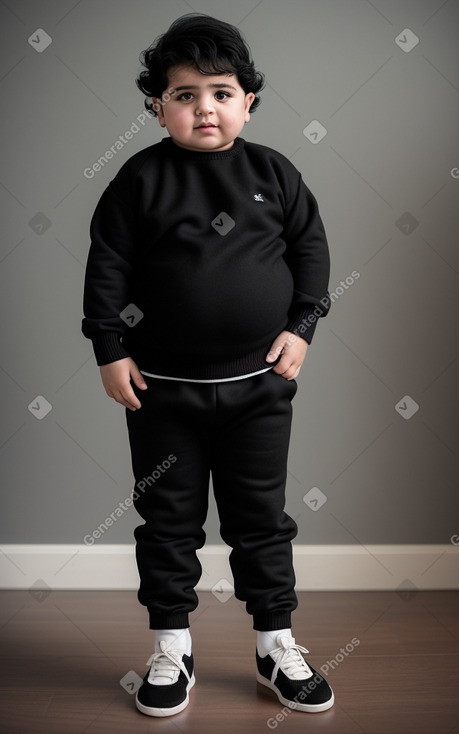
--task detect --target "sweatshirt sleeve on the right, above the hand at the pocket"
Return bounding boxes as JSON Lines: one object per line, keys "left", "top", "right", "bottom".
{"left": 284, "top": 172, "right": 330, "bottom": 343}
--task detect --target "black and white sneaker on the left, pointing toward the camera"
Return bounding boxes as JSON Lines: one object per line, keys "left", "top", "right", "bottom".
{"left": 135, "top": 640, "right": 195, "bottom": 716}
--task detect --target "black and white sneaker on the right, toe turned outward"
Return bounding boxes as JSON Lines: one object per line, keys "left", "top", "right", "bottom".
{"left": 256, "top": 635, "right": 335, "bottom": 713}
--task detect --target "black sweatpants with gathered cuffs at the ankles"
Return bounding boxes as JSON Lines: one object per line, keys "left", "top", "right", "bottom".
{"left": 126, "top": 370, "right": 297, "bottom": 630}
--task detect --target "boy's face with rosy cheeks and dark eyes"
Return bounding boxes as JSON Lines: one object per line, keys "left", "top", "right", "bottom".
{"left": 153, "top": 66, "right": 255, "bottom": 152}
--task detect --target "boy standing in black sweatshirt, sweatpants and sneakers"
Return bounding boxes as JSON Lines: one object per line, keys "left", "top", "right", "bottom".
{"left": 83, "top": 14, "right": 333, "bottom": 716}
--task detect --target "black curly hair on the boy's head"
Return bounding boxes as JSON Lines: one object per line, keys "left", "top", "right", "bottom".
{"left": 135, "top": 13, "right": 264, "bottom": 115}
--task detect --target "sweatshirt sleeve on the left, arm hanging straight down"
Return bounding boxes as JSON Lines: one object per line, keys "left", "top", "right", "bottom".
{"left": 82, "top": 181, "right": 137, "bottom": 366}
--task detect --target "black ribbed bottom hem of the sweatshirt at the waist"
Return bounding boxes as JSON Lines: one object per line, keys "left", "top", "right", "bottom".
{"left": 126, "top": 344, "right": 276, "bottom": 380}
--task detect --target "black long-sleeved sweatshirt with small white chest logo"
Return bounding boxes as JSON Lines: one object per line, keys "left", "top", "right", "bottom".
{"left": 82, "top": 138, "right": 330, "bottom": 380}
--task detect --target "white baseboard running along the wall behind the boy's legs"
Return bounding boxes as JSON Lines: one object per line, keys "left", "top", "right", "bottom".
{"left": 0, "top": 543, "right": 459, "bottom": 593}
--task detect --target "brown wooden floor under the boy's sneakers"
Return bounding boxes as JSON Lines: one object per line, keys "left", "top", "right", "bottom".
{"left": 0, "top": 591, "right": 459, "bottom": 734}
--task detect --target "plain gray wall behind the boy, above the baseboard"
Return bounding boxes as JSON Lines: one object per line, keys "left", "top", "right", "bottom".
{"left": 0, "top": 0, "right": 459, "bottom": 544}
